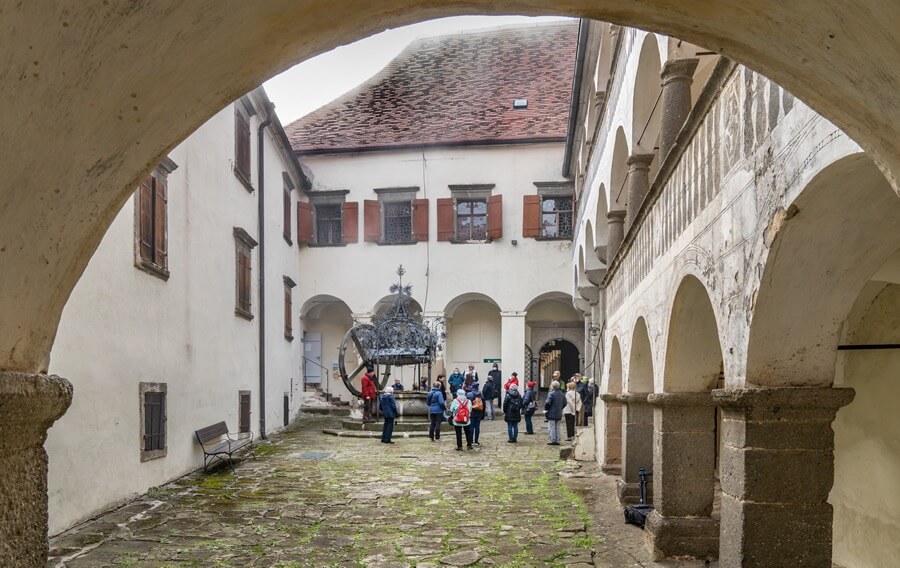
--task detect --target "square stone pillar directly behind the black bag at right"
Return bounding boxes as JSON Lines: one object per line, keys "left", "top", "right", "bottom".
{"left": 618, "top": 393, "right": 653, "bottom": 505}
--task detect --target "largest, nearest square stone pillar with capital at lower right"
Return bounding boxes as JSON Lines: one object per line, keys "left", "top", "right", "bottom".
{"left": 713, "top": 387, "right": 854, "bottom": 568}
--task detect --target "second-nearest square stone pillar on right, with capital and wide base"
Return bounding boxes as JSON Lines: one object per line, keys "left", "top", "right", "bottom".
{"left": 646, "top": 392, "right": 719, "bottom": 560}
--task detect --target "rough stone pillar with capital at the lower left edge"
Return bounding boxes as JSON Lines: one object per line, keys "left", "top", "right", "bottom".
{"left": 0, "top": 371, "right": 72, "bottom": 568}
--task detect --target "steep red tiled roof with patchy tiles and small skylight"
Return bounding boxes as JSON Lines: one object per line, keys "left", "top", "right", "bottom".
{"left": 285, "top": 20, "right": 578, "bottom": 154}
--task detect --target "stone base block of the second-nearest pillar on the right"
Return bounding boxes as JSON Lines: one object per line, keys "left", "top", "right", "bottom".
{"left": 644, "top": 511, "right": 719, "bottom": 561}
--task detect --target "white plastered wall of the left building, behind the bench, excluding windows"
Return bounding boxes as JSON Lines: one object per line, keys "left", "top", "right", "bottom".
{"left": 47, "top": 90, "right": 301, "bottom": 533}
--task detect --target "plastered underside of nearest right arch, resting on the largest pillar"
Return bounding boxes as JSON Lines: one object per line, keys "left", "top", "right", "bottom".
{"left": 746, "top": 154, "right": 900, "bottom": 386}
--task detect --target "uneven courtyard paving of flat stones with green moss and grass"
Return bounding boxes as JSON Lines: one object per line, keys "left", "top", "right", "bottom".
{"left": 48, "top": 418, "right": 712, "bottom": 568}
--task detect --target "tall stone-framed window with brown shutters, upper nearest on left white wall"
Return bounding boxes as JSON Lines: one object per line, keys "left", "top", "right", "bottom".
{"left": 134, "top": 157, "right": 178, "bottom": 281}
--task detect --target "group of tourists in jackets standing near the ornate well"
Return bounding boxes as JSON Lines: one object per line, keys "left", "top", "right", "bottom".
{"left": 362, "top": 364, "right": 597, "bottom": 452}
